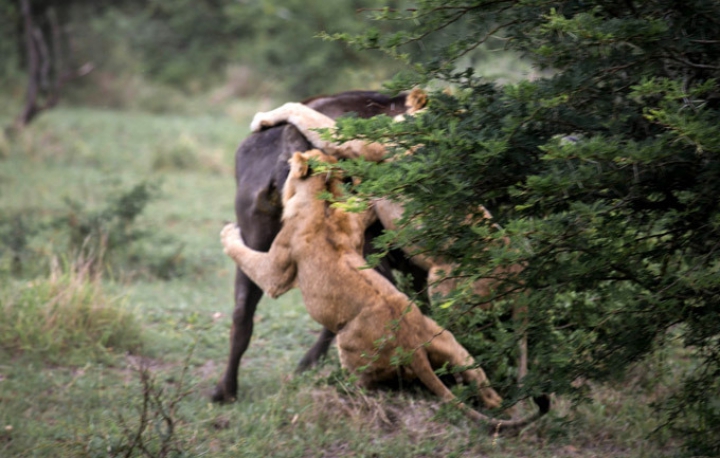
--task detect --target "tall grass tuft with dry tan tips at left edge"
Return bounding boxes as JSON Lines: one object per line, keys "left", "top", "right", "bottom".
{"left": 0, "top": 262, "right": 142, "bottom": 364}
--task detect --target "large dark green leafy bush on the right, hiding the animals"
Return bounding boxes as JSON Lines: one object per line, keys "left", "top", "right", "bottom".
{"left": 330, "top": 0, "right": 720, "bottom": 455}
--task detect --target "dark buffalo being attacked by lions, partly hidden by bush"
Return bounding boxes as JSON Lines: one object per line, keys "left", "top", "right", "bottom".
{"left": 212, "top": 91, "right": 427, "bottom": 402}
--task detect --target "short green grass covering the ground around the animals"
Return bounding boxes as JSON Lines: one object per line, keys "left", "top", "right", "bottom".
{"left": 0, "top": 98, "right": 675, "bottom": 457}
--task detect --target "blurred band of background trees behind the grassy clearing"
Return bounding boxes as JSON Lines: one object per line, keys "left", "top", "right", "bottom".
{"left": 0, "top": 0, "right": 444, "bottom": 124}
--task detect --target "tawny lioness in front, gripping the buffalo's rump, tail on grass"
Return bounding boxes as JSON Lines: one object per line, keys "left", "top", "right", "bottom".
{"left": 221, "top": 150, "right": 546, "bottom": 430}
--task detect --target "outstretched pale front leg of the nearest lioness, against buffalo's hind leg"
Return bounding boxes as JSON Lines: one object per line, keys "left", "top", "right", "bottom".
{"left": 220, "top": 223, "right": 297, "bottom": 298}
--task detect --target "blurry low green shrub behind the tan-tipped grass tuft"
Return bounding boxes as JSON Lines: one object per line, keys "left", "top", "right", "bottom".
{"left": 0, "top": 178, "right": 187, "bottom": 280}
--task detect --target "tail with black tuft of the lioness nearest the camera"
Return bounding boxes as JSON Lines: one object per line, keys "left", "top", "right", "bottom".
{"left": 411, "top": 351, "right": 550, "bottom": 432}
